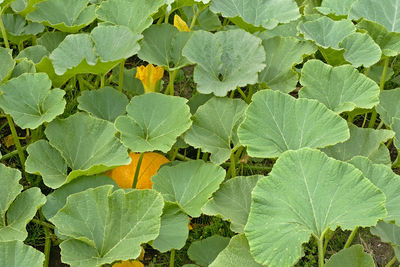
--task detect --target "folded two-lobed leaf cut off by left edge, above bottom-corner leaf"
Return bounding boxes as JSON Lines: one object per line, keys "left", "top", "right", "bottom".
{"left": 0, "top": 164, "right": 46, "bottom": 242}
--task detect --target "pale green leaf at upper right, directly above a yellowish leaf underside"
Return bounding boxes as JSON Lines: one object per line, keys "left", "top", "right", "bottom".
{"left": 298, "top": 17, "right": 356, "bottom": 49}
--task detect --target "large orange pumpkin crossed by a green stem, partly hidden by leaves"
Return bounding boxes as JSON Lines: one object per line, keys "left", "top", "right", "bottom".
{"left": 107, "top": 152, "right": 169, "bottom": 189}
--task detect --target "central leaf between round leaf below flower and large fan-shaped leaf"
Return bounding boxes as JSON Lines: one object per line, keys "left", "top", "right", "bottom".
{"left": 184, "top": 97, "right": 247, "bottom": 165}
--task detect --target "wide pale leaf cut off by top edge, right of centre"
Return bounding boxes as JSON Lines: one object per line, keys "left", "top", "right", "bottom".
{"left": 210, "top": 0, "right": 300, "bottom": 29}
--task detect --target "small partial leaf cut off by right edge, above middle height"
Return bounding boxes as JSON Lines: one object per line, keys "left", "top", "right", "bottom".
{"left": 376, "top": 88, "right": 400, "bottom": 126}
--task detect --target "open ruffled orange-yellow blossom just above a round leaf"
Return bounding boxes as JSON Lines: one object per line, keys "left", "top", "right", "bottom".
{"left": 136, "top": 64, "right": 164, "bottom": 93}
